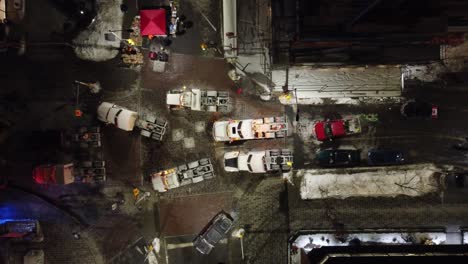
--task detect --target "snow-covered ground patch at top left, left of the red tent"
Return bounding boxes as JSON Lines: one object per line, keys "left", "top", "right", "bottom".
{"left": 73, "top": 0, "right": 123, "bottom": 61}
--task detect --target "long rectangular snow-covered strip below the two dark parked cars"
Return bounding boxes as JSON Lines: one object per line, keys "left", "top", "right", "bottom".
{"left": 299, "top": 164, "right": 440, "bottom": 199}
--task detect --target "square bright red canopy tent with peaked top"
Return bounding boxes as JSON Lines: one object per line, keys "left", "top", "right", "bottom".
{"left": 140, "top": 8, "right": 167, "bottom": 36}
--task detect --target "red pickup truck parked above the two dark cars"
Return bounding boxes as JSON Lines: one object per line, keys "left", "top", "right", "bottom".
{"left": 314, "top": 117, "right": 361, "bottom": 141}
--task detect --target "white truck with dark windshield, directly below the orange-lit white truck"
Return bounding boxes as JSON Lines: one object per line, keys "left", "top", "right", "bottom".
{"left": 224, "top": 149, "right": 293, "bottom": 173}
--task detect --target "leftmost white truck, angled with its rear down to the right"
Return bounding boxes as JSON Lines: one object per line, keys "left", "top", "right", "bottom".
{"left": 97, "top": 102, "right": 167, "bottom": 140}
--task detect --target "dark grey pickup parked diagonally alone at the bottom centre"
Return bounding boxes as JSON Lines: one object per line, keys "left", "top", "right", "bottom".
{"left": 193, "top": 212, "right": 234, "bottom": 255}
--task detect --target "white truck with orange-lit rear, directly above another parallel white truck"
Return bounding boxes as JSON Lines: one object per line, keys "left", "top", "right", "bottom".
{"left": 213, "top": 117, "right": 288, "bottom": 142}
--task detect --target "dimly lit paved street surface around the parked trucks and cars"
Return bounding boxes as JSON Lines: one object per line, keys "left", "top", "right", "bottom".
{"left": 0, "top": 0, "right": 468, "bottom": 264}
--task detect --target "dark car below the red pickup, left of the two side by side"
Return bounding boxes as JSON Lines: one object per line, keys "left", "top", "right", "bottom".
{"left": 315, "top": 149, "right": 361, "bottom": 167}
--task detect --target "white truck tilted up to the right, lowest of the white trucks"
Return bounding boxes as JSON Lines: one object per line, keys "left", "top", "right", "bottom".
{"left": 151, "top": 159, "right": 215, "bottom": 192}
